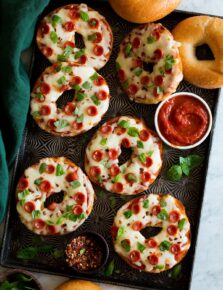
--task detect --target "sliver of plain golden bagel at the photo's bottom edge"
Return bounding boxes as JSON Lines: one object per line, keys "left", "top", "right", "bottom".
{"left": 55, "top": 280, "right": 102, "bottom": 290}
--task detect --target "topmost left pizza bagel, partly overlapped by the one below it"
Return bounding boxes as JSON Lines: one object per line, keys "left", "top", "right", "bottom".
{"left": 36, "top": 4, "right": 113, "bottom": 70}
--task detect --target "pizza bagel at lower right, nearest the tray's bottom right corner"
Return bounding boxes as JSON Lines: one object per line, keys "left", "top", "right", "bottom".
{"left": 112, "top": 194, "right": 191, "bottom": 273}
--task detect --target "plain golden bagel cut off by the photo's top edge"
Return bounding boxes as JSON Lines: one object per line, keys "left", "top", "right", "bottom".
{"left": 109, "top": 0, "right": 180, "bottom": 23}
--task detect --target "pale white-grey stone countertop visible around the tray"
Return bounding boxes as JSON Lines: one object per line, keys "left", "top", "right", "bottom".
{"left": 0, "top": 0, "right": 223, "bottom": 290}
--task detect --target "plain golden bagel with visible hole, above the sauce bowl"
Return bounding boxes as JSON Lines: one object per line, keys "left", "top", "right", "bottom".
{"left": 173, "top": 16, "right": 223, "bottom": 89}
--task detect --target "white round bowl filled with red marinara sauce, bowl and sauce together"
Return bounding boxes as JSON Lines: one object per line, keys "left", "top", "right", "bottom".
{"left": 155, "top": 92, "right": 212, "bottom": 149}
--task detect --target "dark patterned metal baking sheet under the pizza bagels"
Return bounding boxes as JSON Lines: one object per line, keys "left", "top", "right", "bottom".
{"left": 1, "top": 1, "right": 219, "bottom": 290}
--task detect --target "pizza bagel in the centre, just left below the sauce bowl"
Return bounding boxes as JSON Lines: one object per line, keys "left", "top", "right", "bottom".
{"left": 85, "top": 116, "right": 162, "bottom": 195}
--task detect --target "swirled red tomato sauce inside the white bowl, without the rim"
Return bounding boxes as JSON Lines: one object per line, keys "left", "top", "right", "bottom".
{"left": 158, "top": 95, "right": 209, "bottom": 146}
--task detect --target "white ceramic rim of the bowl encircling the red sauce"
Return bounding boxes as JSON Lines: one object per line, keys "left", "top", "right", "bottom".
{"left": 154, "top": 92, "right": 212, "bottom": 150}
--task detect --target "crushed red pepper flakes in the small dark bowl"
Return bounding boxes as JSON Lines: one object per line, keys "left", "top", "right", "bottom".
{"left": 65, "top": 235, "right": 103, "bottom": 271}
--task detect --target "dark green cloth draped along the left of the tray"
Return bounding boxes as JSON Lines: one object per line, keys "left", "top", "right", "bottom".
{"left": 0, "top": 0, "right": 49, "bottom": 222}
